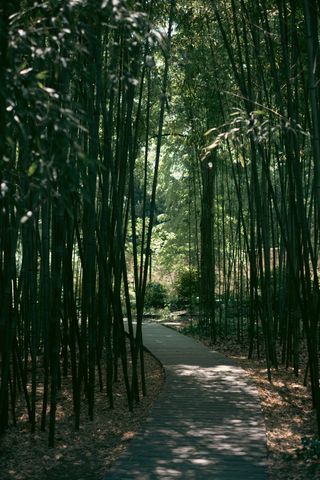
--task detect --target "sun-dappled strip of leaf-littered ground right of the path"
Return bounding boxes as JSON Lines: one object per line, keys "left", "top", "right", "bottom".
{"left": 162, "top": 315, "right": 320, "bottom": 480}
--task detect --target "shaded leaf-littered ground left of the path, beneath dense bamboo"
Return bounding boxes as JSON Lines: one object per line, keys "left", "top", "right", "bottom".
{"left": 0, "top": 348, "right": 164, "bottom": 480}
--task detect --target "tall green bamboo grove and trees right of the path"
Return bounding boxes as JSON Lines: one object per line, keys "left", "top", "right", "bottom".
{"left": 171, "top": 0, "right": 320, "bottom": 433}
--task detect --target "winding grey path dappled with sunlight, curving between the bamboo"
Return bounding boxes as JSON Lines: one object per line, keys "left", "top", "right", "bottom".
{"left": 105, "top": 324, "right": 267, "bottom": 480}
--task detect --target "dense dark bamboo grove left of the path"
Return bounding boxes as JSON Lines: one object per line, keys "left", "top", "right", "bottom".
{"left": 0, "top": 0, "right": 173, "bottom": 446}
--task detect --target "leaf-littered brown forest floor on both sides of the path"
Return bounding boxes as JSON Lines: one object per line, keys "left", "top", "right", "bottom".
{"left": 0, "top": 319, "right": 320, "bottom": 480}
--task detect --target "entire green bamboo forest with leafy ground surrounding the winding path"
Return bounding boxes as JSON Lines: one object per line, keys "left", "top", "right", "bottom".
{"left": 0, "top": 0, "right": 320, "bottom": 480}
